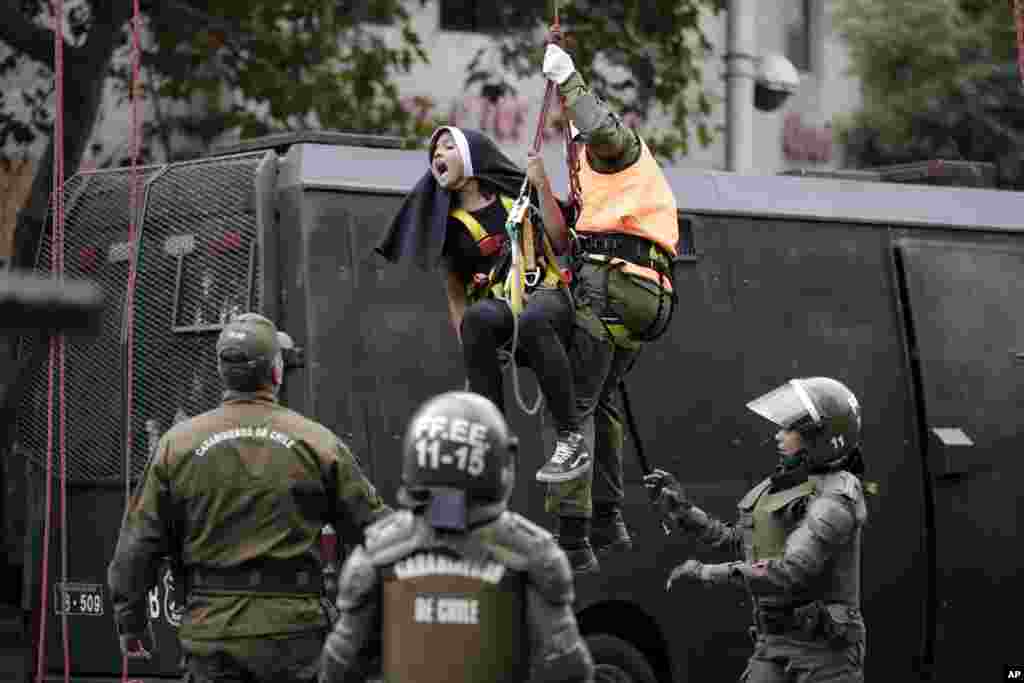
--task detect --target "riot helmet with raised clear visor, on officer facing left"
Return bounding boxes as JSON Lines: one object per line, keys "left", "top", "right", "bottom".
{"left": 746, "top": 377, "right": 860, "bottom": 470}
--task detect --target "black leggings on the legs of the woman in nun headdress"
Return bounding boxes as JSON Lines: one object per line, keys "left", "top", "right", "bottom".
{"left": 462, "top": 289, "right": 580, "bottom": 430}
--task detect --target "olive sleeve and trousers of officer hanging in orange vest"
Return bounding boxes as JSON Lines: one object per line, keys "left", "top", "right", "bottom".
{"left": 545, "top": 73, "right": 671, "bottom": 568}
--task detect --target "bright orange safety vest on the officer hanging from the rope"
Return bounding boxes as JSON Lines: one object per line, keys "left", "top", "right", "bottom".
{"left": 575, "top": 139, "right": 679, "bottom": 287}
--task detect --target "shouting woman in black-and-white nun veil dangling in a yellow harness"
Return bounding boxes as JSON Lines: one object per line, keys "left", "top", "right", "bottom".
{"left": 377, "top": 126, "right": 593, "bottom": 481}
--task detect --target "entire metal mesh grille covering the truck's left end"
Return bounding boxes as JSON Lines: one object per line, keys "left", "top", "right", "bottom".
{"left": 18, "top": 153, "right": 263, "bottom": 480}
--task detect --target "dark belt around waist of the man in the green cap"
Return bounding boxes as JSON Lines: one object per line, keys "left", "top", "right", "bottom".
{"left": 188, "top": 558, "right": 323, "bottom": 595}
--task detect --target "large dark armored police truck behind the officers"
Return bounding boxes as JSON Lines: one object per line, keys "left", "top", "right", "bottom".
{"left": 0, "top": 134, "right": 1024, "bottom": 683}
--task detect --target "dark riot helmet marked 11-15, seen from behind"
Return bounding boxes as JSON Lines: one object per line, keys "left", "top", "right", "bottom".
{"left": 397, "top": 391, "right": 518, "bottom": 529}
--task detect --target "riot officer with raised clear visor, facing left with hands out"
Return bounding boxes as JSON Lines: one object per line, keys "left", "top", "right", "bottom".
{"left": 645, "top": 377, "right": 867, "bottom": 683}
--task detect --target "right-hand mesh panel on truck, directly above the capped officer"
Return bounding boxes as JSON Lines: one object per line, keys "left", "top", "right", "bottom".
{"left": 131, "top": 153, "right": 263, "bottom": 475}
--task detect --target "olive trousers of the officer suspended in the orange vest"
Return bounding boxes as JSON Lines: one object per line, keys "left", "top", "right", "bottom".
{"left": 545, "top": 261, "right": 671, "bottom": 517}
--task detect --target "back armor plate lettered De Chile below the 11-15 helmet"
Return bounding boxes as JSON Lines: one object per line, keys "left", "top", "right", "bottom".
{"left": 381, "top": 548, "right": 529, "bottom": 683}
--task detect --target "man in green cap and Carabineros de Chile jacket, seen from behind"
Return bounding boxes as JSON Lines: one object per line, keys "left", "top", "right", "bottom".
{"left": 108, "top": 313, "right": 390, "bottom": 683}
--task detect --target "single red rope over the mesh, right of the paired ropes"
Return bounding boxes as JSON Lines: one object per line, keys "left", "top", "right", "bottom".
{"left": 121, "top": 0, "right": 142, "bottom": 683}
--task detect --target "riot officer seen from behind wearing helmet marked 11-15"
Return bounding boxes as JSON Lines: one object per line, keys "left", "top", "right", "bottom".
{"left": 319, "top": 391, "right": 593, "bottom": 683}
